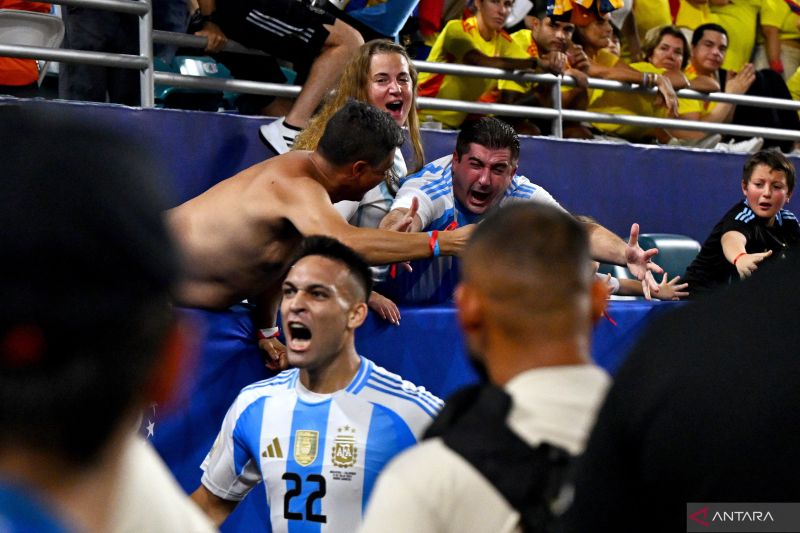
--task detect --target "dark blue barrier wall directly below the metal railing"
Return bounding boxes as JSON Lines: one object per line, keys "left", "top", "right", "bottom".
{"left": 6, "top": 98, "right": 800, "bottom": 241}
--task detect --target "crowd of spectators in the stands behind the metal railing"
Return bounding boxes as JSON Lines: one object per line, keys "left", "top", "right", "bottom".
{"left": 0, "top": 0, "right": 800, "bottom": 153}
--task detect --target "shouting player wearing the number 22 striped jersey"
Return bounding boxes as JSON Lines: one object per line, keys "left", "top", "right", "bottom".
{"left": 192, "top": 237, "right": 443, "bottom": 532}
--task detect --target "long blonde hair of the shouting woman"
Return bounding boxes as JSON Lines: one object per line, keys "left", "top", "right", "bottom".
{"left": 293, "top": 39, "right": 425, "bottom": 177}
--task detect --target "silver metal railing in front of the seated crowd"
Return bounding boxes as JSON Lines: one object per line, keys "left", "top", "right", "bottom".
{"left": 0, "top": 0, "right": 800, "bottom": 140}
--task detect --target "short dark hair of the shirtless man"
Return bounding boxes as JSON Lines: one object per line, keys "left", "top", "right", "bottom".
{"left": 317, "top": 99, "right": 403, "bottom": 167}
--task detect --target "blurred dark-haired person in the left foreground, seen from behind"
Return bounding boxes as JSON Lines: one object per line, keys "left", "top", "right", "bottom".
{"left": 0, "top": 104, "right": 214, "bottom": 533}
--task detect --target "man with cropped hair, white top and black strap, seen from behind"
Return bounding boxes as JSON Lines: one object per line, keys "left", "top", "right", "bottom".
{"left": 362, "top": 202, "right": 609, "bottom": 532}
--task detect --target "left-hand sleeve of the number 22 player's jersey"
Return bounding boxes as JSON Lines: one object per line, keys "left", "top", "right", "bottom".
{"left": 200, "top": 399, "right": 261, "bottom": 501}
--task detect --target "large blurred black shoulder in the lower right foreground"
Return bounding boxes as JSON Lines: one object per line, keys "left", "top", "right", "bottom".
{"left": 565, "top": 242, "right": 800, "bottom": 533}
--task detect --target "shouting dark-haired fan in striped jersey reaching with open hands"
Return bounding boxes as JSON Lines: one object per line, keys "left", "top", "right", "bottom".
{"left": 381, "top": 117, "right": 662, "bottom": 303}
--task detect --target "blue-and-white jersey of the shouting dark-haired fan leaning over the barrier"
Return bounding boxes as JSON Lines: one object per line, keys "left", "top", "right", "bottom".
{"left": 379, "top": 155, "right": 563, "bottom": 304}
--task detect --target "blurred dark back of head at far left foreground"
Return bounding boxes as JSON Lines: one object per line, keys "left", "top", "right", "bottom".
{"left": 0, "top": 102, "right": 178, "bottom": 465}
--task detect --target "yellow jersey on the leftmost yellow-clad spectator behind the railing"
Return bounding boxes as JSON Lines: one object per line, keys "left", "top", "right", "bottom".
{"left": 418, "top": 17, "right": 530, "bottom": 128}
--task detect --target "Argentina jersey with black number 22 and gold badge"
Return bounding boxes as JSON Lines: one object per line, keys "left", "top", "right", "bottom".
{"left": 197, "top": 357, "right": 443, "bottom": 533}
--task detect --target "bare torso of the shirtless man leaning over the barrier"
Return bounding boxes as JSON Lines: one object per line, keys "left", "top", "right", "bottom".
{"left": 167, "top": 152, "right": 320, "bottom": 309}
